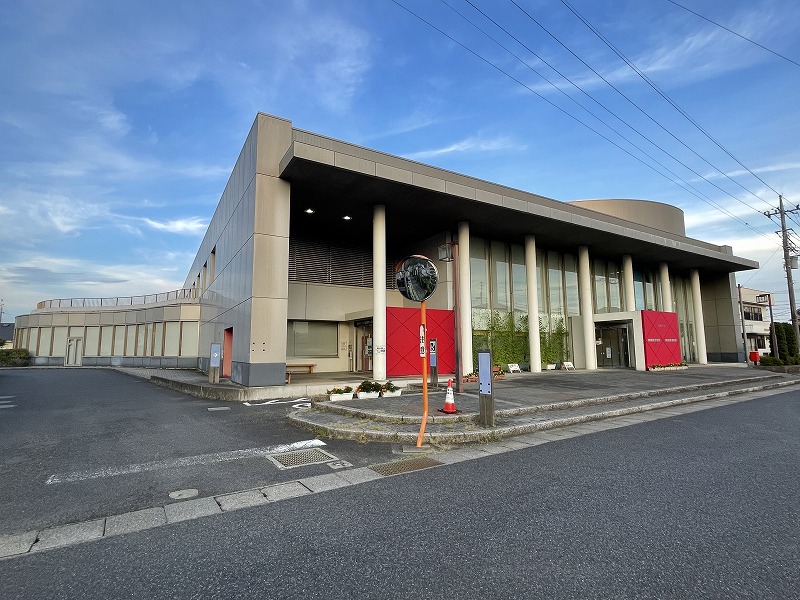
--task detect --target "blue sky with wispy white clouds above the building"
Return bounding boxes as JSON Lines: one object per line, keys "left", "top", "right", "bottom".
{"left": 0, "top": 0, "right": 800, "bottom": 321}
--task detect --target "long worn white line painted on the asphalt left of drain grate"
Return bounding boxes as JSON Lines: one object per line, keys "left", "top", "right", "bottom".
{"left": 45, "top": 440, "right": 325, "bottom": 485}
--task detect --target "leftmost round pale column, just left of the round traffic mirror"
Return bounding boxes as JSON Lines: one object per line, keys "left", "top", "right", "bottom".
{"left": 372, "top": 205, "right": 386, "bottom": 380}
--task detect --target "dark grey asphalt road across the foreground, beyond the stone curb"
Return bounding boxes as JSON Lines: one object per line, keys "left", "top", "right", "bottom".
{"left": 0, "top": 382, "right": 800, "bottom": 599}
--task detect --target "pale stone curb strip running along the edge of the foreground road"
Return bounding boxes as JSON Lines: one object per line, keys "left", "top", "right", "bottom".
{"left": 0, "top": 381, "right": 788, "bottom": 560}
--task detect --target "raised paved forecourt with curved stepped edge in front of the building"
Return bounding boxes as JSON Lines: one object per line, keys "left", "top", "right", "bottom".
{"left": 119, "top": 363, "right": 800, "bottom": 445}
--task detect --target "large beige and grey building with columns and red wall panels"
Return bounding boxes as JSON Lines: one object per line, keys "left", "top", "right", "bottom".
{"left": 15, "top": 114, "right": 758, "bottom": 386}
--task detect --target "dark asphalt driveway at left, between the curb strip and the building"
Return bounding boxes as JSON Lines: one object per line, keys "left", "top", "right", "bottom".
{"left": 0, "top": 369, "right": 392, "bottom": 535}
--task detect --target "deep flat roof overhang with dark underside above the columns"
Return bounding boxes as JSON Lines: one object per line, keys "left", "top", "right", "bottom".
{"left": 279, "top": 130, "right": 758, "bottom": 273}
